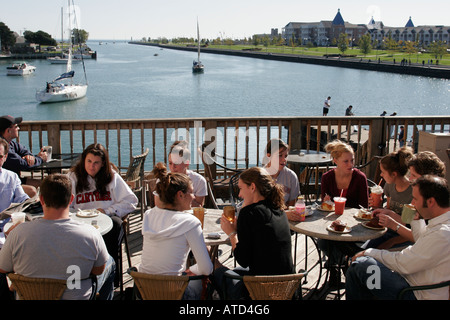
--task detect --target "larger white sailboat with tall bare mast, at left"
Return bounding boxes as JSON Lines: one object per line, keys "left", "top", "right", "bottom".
{"left": 36, "top": 0, "right": 88, "bottom": 103}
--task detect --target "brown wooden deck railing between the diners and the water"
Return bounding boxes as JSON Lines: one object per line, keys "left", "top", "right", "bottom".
{"left": 19, "top": 116, "right": 450, "bottom": 181}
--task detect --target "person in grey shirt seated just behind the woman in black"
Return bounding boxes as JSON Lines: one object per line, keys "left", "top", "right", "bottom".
{"left": 264, "top": 139, "right": 300, "bottom": 207}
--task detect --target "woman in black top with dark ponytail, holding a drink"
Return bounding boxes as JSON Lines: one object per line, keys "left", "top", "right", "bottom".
{"left": 214, "top": 167, "right": 295, "bottom": 299}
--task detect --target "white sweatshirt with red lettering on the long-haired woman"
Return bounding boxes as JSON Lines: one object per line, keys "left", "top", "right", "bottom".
{"left": 69, "top": 172, "right": 138, "bottom": 217}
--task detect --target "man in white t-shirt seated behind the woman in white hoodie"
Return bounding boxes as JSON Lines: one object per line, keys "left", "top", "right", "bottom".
{"left": 169, "top": 140, "right": 208, "bottom": 207}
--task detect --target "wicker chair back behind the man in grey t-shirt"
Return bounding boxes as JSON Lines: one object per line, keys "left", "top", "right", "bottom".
{"left": 8, "top": 273, "right": 67, "bottom": 300}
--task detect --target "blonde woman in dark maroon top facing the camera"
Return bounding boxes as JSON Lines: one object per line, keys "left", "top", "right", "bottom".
{"left": 321, "top": 140, "right": 369, "bottom": 208}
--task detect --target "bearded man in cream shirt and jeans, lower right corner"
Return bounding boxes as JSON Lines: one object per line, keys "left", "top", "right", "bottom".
{"left": 345, "top": 175, "right": 450, "bottom": 300}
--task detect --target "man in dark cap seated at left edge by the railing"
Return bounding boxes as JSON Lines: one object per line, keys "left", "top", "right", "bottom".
{"left": 0, "top": 115, "right": 47, "bottom": 197}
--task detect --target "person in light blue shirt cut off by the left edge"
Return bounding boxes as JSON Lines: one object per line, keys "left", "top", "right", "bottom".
{"left": 0, "top": 138, "right": 28, "bottom": 212}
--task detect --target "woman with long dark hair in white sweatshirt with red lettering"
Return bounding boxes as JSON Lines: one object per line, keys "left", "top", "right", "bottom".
{"left": 69, "top": 143, "right": 138, "bottom": 279}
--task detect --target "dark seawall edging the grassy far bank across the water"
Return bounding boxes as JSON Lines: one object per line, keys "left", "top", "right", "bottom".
{"left": 128, "top": 41, "right": 450, "bottom": 79}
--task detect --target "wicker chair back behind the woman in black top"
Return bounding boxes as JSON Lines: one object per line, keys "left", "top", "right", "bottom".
{"left": 243, "top": 273, "right": 304, "bottom": 300}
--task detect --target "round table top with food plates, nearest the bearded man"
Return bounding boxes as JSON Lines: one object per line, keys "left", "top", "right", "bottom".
{"left": 289, "top": 208, "right": 387, "bottom": 241}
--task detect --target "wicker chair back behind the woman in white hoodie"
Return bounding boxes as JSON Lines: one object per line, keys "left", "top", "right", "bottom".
{"left": 128, "top": 268, "right": 204, "bottom": 300}
